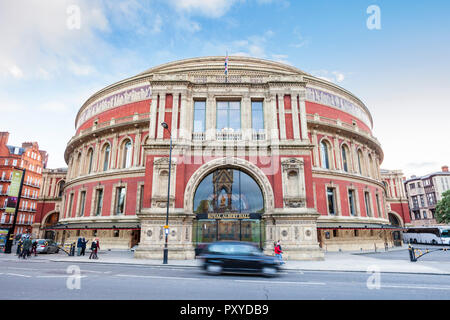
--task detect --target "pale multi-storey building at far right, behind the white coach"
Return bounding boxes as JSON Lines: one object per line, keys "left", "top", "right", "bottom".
{"left": 405, "top": 166, "right": 450, "bottom": 226}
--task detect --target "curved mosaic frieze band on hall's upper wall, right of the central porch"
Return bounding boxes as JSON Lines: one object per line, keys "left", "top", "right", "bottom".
{"left": 306, "top": 88, "right": 372, "bottom": 128}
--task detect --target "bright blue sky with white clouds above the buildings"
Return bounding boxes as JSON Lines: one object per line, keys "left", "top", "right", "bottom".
{"left": 0, "top": 0, "right": 450, "bottom": 178}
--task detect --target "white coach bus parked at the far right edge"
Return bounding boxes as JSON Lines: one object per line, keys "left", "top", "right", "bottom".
{"left": 403, "top": 226, "right": 450, "bottom": 245}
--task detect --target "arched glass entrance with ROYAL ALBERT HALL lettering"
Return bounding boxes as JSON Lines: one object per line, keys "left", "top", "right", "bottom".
{"left": 193, "top": 167, "right": 265, "bottom": 249}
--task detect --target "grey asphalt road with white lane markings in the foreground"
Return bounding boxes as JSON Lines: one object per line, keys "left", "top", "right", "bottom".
{"left": 0, "top": 258, "right": 450, "bottom": 300}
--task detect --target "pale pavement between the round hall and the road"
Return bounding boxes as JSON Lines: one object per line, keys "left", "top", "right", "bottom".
{"left": 0, "top": 247, "right": 450, "bottom": 275}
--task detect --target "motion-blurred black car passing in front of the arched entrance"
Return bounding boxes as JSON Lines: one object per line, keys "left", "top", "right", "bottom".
{"left": 198, "top": 241, "right": 280, "bottom": 276}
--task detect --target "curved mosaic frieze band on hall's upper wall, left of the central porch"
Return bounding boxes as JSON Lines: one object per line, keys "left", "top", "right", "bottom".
{"left": 76, "top": 85, "right": 152, "bottom": 129}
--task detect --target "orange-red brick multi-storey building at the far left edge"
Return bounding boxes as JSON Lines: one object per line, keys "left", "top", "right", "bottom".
{"left": 0, "top": 132, "right": 48, "bottom": 234}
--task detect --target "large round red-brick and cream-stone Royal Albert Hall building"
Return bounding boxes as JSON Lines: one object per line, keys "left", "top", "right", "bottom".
{"left": 52, "top": 56, "right": 395, "bottom": 260}
